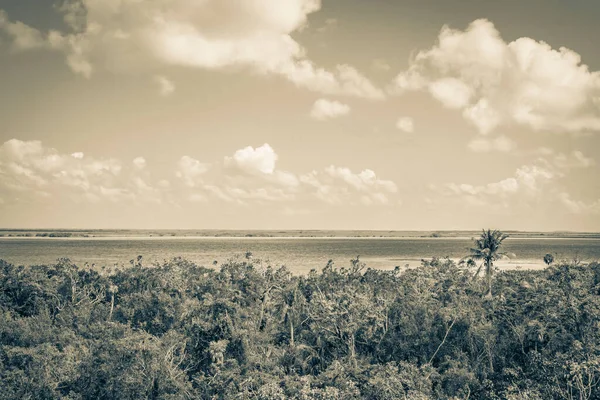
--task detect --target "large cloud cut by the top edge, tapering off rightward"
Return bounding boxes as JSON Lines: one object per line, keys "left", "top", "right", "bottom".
{"left": 0, "top": 0, "right": 385, "bottom": 99}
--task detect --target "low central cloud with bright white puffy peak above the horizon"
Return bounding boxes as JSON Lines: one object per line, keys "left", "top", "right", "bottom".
{"left": 178, "top": 143, "right": 398, "bottom": 208}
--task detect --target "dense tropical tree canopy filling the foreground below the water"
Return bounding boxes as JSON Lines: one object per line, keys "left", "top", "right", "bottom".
{"left": 0, "top": 254, "right": 600, "bottom": 400}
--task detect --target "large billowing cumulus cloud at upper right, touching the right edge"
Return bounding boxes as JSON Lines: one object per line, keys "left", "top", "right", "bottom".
{"left": 392, "top": 19, "right": 600, "bottom": 134}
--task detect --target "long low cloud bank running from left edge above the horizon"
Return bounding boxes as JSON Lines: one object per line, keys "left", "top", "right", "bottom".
{"left": 0, "top": 139, "right": 399, "bottom": 209}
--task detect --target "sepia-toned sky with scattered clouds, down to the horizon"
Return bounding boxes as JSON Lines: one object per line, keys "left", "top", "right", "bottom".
{"left": 0, "top": 0, "right": 600, "bottom": 231}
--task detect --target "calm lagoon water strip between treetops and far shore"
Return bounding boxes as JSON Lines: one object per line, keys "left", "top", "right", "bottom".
{"left": 0, "top": 237, "right": 600, "bottom": 273}
